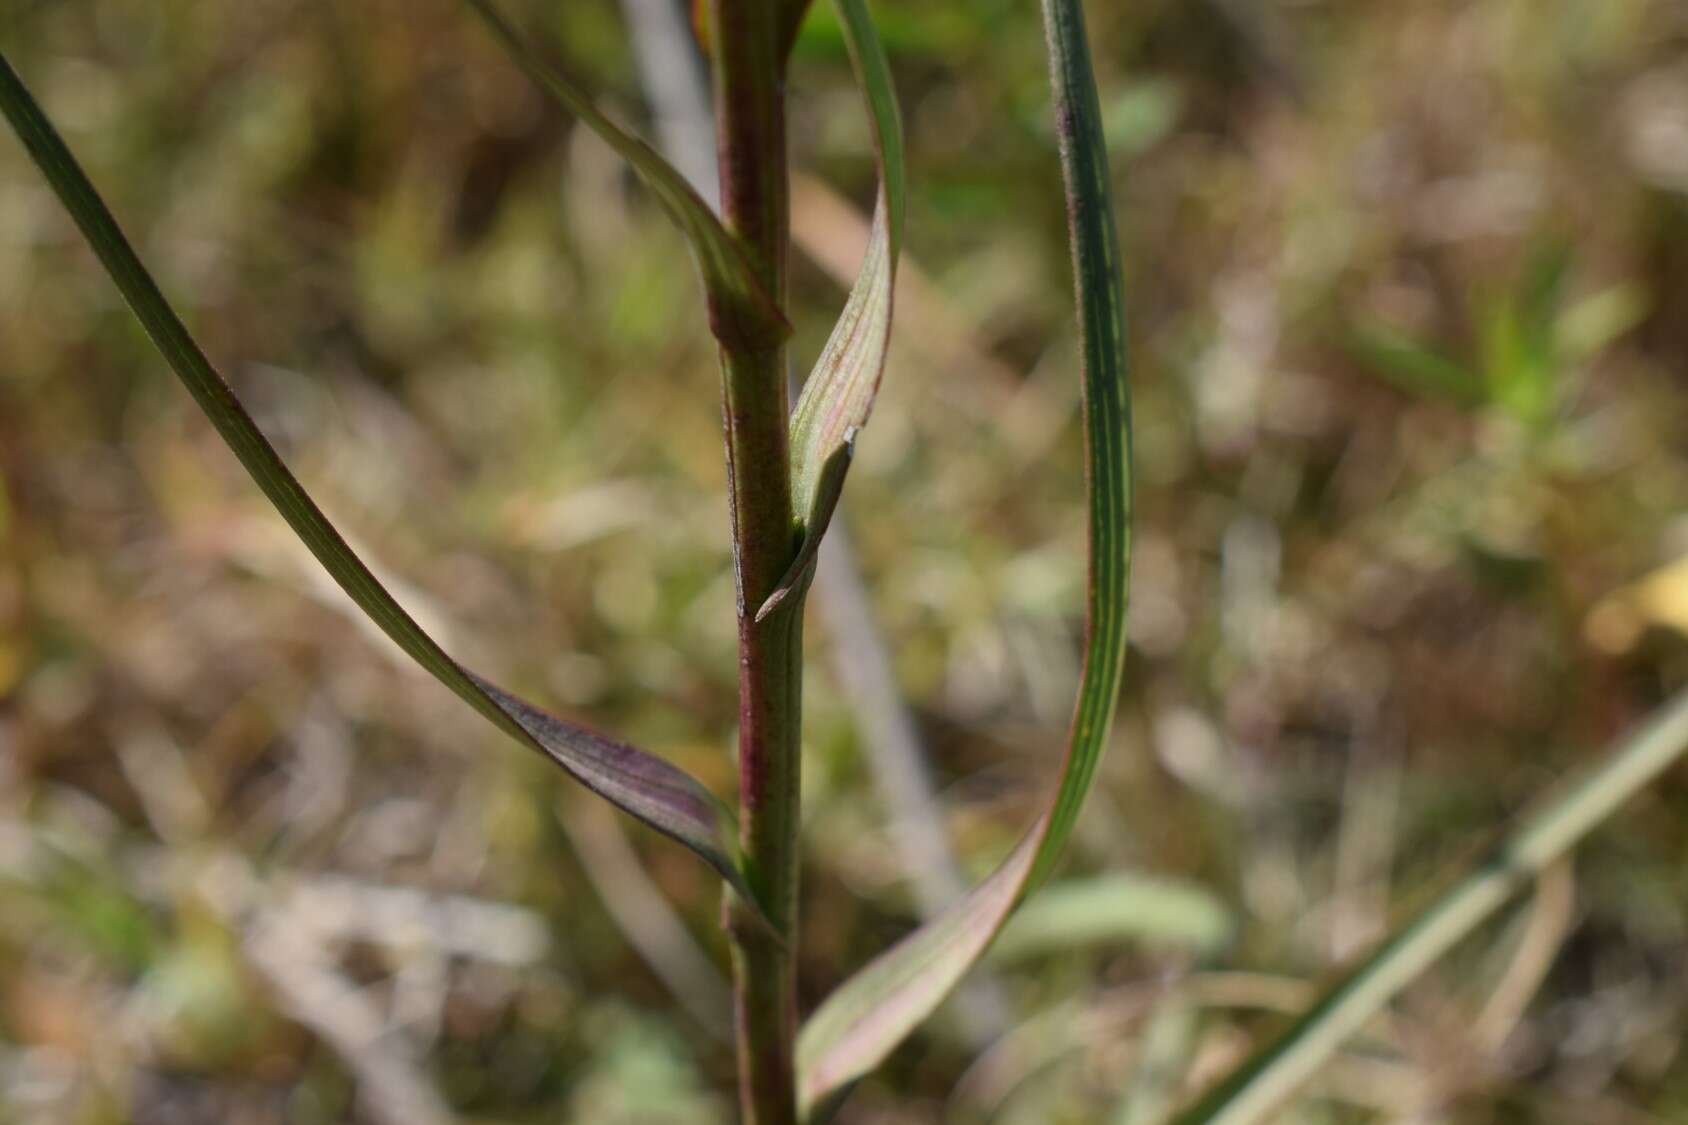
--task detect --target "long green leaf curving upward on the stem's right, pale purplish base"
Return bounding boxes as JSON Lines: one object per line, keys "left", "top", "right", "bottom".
{"left": 797, "top": 0, "right": 1131, "bottom": 1118}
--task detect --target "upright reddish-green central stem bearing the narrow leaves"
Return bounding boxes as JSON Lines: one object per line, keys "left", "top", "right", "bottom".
{"left": 711, "top": 0, "right": 803, "bottom": 1125}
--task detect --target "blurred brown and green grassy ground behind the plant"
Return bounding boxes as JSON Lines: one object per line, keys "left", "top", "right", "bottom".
{"left": 0, "top": 0, "right": 1688, "bottom": 1125}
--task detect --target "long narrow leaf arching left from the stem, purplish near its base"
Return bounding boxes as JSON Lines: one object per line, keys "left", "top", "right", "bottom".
{"left": 0, "top": 46, "right": 769, "bottom": 918}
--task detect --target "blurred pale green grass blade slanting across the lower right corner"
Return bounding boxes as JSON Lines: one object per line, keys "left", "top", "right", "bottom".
{"left": 1177, "top": 691, "right": 1688, "bottom": 1125}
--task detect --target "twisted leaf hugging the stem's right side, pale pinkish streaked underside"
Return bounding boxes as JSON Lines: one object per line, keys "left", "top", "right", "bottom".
{"left": 756, "top": 0, "right": 906, "bottom": 620}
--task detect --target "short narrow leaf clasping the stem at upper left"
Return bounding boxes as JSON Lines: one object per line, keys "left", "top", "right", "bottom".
{"left": 464, "top": 0, "right": 792, "bottom": 348}
